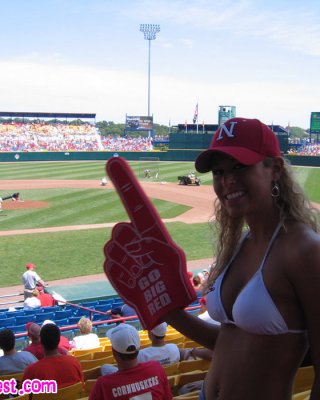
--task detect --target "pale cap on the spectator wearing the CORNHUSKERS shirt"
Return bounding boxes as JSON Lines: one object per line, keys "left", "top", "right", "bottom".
{"left": 107, "top": 324, "right": 140, "bottom": 354}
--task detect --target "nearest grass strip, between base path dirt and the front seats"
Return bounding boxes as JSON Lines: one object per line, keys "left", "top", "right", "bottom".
{"left": 0, "top": 223, "right": 212, "bottom": 287}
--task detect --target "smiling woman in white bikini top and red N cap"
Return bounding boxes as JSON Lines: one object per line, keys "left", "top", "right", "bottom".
{"left": 166, "top": 118, "right": 320, "bottom": 400}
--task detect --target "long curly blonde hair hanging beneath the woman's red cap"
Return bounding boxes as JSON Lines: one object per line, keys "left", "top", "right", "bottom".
{"left": 205, "top": 158, "right": 319, "bottom": 292}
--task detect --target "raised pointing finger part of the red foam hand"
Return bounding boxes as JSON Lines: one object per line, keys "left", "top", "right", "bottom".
{"left": 106, "top": 157, "right": 172, "bottom": 241}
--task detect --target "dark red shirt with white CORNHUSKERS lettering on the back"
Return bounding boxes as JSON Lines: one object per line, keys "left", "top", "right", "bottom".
{"left": 89, "top": 361, "right": 172, "bottom": 400}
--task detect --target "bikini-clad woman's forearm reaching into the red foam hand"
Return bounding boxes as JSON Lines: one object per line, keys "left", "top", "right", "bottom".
{"left": 164, "top": 310, "right": 220, "bottom": 350}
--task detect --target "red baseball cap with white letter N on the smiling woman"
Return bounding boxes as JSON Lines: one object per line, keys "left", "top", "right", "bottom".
{"left": 195, "top": 118, "right": 281, "bottom": 172}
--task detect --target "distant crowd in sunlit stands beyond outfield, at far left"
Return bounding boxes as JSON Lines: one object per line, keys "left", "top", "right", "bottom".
{"left": 0, "top": 122, "right": 153, "bottom": 152}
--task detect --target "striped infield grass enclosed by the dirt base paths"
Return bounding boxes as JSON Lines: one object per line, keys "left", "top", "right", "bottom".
{"left": 0, "top": 189, "right": 190, "bottom": 231}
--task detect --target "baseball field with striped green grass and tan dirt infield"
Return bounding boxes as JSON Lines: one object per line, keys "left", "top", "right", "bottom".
{"left": 0, "top": 161, "right": 320, "bottom": 287}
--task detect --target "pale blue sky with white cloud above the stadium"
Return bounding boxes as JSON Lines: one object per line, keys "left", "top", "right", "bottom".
{"left": 0, "top": 0, "right": 320, "bottom": 128}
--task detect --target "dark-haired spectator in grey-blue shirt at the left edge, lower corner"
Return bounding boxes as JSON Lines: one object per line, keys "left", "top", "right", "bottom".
{"left": 0, "top": 329, "right": 38, "bottom": 375}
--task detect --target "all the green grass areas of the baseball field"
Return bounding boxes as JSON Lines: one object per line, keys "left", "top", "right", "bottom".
{"left": 0, "top": 161, "right": 320, "bottom": 287}
